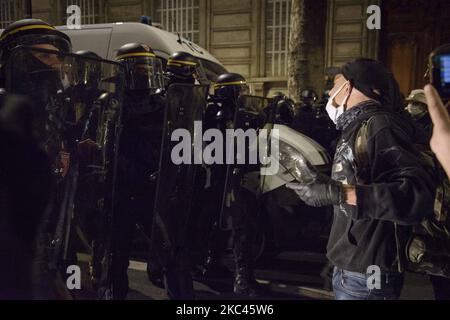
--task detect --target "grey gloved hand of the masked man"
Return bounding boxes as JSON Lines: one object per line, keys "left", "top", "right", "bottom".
{"left": 286, "top": 173, "right": 346, "bottom": 207}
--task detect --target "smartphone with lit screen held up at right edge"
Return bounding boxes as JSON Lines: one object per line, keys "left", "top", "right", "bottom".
{"left": 429, "top": 44, "right": 450, "bottom": 100}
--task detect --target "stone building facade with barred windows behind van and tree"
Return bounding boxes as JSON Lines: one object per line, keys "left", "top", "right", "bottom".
{"left": 0, "top": 0, "right": 450, "bottom": 95}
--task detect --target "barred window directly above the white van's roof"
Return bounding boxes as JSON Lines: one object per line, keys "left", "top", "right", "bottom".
{"left": 155, "top": 0, "right": 199, "bottom": 43}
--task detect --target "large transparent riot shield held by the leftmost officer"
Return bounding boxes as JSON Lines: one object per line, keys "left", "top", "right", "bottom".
{"left": 5, "top": 47, "right": 123, "bottom": 298}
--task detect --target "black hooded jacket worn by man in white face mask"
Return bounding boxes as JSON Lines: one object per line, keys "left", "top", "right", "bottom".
{"left": 327, "top": 103, "right": 435, "bottom": 273}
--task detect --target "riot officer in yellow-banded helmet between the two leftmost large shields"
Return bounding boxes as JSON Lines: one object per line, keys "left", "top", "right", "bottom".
{"left": 112, "top": 43, "right": 164, "bottom": 299}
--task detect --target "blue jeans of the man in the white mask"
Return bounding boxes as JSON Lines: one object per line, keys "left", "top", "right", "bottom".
{"left": 333, "top": 267, "right": 404, "bottom": 300}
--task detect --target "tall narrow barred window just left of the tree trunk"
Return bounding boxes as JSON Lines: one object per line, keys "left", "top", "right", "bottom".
{"left": 266, "top": 0, "right": 291, "bottom": 77}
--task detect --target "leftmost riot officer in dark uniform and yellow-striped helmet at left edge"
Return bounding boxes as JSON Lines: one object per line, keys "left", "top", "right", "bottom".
{"left": 0, "top": 19, "right": 71, "bottom": 298}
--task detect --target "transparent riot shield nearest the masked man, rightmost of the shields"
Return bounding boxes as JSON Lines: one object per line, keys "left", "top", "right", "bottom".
{"left": 213, "top": 95, "right": 268, "bottom": 260}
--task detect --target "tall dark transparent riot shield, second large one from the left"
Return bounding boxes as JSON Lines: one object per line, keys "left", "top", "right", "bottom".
{"left": 150, "top": 84, "right": 208, "bottom": 266}
